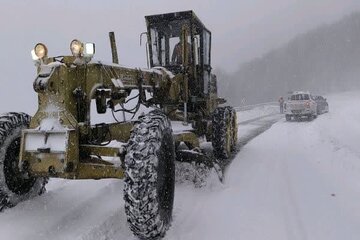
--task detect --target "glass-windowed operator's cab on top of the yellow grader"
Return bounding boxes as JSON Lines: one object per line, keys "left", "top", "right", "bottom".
{"left": 145, "top": 11, "right": 216, "bottom": 98}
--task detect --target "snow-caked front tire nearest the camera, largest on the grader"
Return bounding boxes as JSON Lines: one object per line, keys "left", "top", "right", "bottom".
{"left": 124, "top": 111, "right": 175, "bottom": 239}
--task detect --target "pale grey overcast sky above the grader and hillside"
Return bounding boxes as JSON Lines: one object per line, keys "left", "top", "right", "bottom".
{"left": 0, "top": 0, "right": 360, "bottom": 110}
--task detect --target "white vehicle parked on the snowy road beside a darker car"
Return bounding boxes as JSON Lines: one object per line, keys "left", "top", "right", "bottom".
{"left": 284, "top": 92, "right": 317, "bottom": 121}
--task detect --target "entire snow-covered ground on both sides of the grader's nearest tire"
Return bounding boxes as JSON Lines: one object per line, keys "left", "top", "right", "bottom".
{"left": 0, "top": 92, "right": 360, "bottom": 240}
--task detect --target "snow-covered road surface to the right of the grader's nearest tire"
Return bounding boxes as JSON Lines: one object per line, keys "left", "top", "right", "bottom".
{"left": 167, "top": 93, "right": 360, "bottom": 240}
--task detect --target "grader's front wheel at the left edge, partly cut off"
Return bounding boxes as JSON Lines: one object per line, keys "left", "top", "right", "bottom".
{"left": 0, "top": 113, "right": 48, "bottom": 210}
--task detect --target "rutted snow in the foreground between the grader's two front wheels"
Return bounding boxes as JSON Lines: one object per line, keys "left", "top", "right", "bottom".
{"left": 0, "top": 180, "right": 132, "bottom": 240}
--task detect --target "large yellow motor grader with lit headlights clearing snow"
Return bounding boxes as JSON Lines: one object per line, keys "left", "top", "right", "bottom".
{"left": 0, "top": 11, "right": 237, "bottom": 239}
